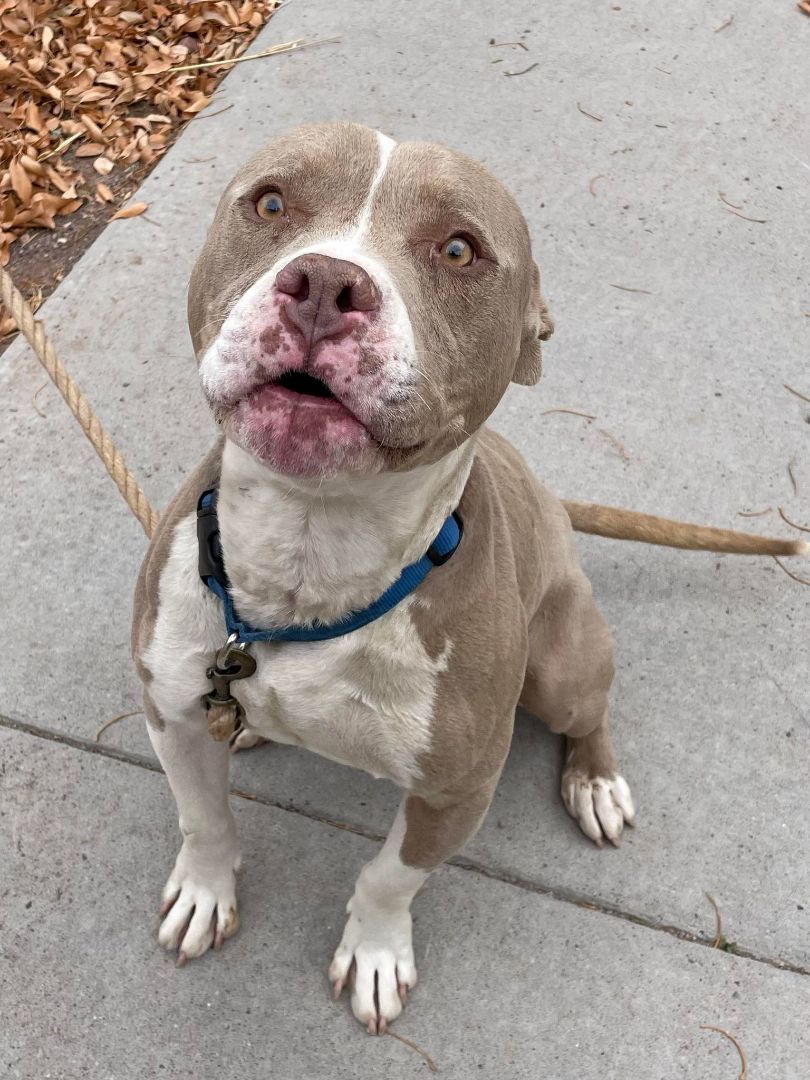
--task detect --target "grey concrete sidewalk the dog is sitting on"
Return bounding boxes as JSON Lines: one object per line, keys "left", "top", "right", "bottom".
{"left": 0, "top": 0, "right": 810, "bottom": 1080}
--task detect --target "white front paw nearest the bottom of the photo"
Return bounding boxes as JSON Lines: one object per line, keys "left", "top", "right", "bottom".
{"left": 329, "top": 896, "right": 416, "bottom": 1035}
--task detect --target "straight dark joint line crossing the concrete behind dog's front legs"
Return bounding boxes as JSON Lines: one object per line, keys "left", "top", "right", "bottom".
{"left": 0, "top": 715, "right": 810, "bottom": 975}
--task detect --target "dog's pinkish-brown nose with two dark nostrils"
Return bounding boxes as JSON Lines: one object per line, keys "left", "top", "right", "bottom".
{"left": 275, "top": 253, "right": 380, "bottom": 346}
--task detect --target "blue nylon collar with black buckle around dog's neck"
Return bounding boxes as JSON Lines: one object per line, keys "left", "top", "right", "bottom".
{"left": 197, "top": 488, "right": 462, "bottom": 643}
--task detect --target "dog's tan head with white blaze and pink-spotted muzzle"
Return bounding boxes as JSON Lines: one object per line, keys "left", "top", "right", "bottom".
{"left": 189, "top": 124, "right": 552, "bottom": 476}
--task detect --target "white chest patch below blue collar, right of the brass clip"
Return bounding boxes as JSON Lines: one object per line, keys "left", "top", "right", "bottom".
{"left": 232, "top": 603, "right": 446, "bottom": 784}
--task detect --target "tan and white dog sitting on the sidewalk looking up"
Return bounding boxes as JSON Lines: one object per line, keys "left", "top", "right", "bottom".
{"left": 133, "top": 124, "right": 799, "bottom": 1032}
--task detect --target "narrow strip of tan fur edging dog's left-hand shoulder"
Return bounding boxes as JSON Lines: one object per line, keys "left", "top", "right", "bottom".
{"left": 132, "top": 438, "right": 224, "bottom": 681}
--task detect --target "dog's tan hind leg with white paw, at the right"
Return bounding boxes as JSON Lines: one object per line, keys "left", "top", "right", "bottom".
{"left": 521, "top": 572, "right": 635, "bottom": 847}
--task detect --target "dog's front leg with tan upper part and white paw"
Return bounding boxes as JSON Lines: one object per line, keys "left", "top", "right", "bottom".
{"left": 329, "top": 784, "right": 495, "bottom": 1035}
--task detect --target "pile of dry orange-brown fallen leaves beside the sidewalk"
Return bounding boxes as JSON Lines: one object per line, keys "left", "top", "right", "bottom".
{"left": 0, "top": 0, "right": 279, "bottom": 334}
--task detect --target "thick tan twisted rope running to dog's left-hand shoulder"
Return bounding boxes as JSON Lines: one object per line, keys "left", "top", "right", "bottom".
{"left": 0, "top": 267, "right": 160, "bottom": 537}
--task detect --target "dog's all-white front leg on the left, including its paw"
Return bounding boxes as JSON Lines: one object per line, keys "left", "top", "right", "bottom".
{"left": 149, "top": 712, "right": 239, "bottom": 964}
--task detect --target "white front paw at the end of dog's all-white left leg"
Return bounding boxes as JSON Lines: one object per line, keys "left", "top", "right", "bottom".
{"left": 158, "top": 840, "right": 239, "bottom": 967}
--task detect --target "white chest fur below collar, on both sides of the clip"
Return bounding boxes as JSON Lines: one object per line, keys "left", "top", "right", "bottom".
{"left": 144, "top": 516, "right": 450, "bottom": 786}
